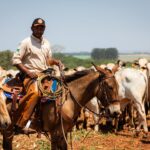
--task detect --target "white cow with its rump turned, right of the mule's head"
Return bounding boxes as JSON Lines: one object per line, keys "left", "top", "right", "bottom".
{"left": 115, "top": 68, "right": 148, "bottom": 133}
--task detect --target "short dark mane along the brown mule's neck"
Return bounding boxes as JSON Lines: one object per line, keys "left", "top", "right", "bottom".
{"left": 65, "top": 69, "right": 94, "bottom": 83}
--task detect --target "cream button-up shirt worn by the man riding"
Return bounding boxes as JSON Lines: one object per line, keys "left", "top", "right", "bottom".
{"left": 12, "top": 35, "right": 52, "bottom": 72}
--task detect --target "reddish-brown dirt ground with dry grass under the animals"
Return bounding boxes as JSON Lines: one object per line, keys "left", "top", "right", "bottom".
{"left": 0, "top": 116, "right": 150, "bottom": 150}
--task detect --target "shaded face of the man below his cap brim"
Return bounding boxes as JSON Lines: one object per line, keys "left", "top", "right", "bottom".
{"left": 31, "top": 25, "right": 45, "bottom": 39}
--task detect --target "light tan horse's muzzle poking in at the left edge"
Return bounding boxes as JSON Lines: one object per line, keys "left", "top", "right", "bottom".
{"left": 0, "top": 90, "right": 11, "bottom": 129}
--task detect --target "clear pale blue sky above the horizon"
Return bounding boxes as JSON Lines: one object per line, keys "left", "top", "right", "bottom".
{"left": 0, "top": 0, "right": 150, "bottom": 53}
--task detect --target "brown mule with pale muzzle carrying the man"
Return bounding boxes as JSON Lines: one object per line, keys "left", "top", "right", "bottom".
{"left": 3, "top": 67, "right": 120, "bottom": 150}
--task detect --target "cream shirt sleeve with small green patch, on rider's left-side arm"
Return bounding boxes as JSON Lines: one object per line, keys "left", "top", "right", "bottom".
{"left": 12, "top": 42, "right": 27, "bottom": 65}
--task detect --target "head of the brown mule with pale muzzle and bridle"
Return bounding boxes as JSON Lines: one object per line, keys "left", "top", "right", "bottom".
{"left": 92, "top": 63, "right": 121, "bottom": 116}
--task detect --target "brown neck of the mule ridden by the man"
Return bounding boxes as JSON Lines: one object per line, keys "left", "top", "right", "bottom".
{"left": 69, "top": 72, "right": 99, "bottom": 106}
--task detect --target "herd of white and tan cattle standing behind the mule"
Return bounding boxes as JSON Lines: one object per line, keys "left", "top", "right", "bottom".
{"left": 0, "top": 58, "right": 150, "bottom": 148}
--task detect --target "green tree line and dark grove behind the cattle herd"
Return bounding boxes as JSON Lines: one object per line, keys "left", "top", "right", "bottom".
{"left": 0, "top": 48, "right": 118, "bottom": 70}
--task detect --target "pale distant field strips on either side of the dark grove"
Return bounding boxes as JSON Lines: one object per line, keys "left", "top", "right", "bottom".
{"left": 73, "top": 54, "right": 150, "bottom": 62}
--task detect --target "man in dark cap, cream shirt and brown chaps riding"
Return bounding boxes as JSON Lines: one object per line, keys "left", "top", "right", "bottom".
{"left": 12, "top": 18, "right": 61, "bottom": 128}
